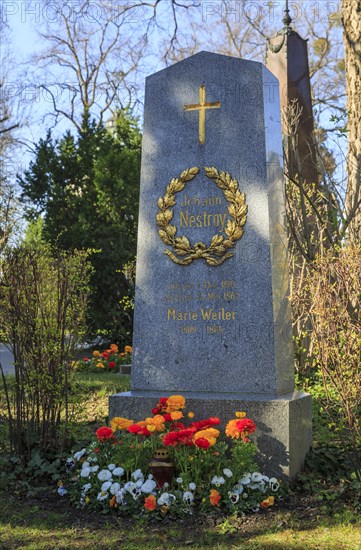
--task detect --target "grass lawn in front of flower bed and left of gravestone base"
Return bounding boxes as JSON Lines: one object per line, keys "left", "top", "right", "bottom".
{"left": 0, "top": 373, "right": 361, "bottom": 550}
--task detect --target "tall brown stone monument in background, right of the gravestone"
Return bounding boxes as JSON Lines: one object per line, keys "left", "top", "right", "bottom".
{"left": 266, "top": 1, "right": 318, "bottom": 188}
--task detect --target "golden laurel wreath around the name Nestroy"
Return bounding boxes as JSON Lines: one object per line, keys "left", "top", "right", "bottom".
{"left": 157, "top": 166, "right": 248, "bottom": 266}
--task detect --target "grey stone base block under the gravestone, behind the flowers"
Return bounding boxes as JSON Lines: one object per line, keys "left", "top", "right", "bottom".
{"left": 109, "top": 391, "right": 312, "bottom": 480}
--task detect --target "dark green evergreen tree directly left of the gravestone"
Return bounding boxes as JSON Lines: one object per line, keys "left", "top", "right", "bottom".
{"left": 19, "top": 112, "right": 141, "bottom": 343}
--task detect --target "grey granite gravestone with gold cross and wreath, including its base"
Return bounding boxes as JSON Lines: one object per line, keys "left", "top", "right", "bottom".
{"left": 110, "top": 52, "right": 311, "bottom": 484}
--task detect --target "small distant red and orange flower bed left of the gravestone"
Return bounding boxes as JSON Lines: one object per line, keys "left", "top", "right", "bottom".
{"left": 75, "top": 344, "right": 133, "bottom": 372}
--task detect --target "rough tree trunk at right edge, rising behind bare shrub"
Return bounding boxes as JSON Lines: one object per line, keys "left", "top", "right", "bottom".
{"left": 342, "top": 0, "right": 361, "bottom": 243}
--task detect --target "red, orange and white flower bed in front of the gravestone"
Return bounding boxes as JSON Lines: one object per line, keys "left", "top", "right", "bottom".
{"left": 58, "top": 395, "right": 282, "bottom": 518}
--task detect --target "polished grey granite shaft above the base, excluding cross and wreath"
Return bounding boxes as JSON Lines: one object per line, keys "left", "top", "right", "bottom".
{"left": 132, "top": 52, "right": 293, "bottom": 395}
